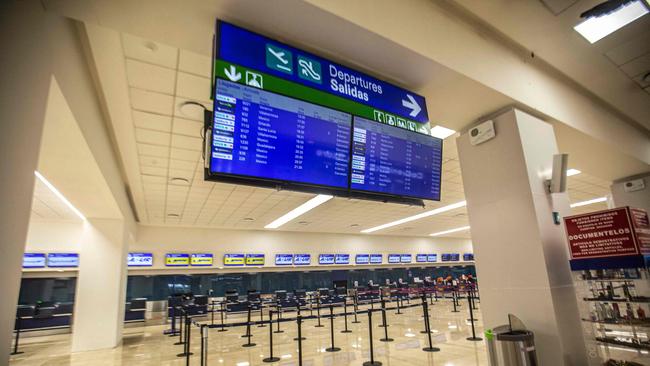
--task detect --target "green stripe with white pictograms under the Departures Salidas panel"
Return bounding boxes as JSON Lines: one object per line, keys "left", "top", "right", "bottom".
{"left": 215, "top": 60, "right": 429, "bottom": 135}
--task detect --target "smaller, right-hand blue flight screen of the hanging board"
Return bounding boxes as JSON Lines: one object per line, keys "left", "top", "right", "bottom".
{"left": 350, "top": 116, "right": 442, "bottom": 201}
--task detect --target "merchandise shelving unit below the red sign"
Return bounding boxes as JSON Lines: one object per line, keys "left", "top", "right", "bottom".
{"left": 573, "top": 267, "right": 650, "bottom": 366}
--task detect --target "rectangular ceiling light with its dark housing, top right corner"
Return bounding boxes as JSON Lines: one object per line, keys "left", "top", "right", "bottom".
{"left": 573, "top": 0, "right": 650, "bottom": 43}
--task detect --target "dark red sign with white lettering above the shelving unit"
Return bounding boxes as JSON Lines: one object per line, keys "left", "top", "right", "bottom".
{"left": 564, "top": 207, "right": 650, "bottom": 259}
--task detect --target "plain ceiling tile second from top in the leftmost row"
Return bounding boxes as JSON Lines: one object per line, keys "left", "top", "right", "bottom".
{"left": 126, "top": 60, "right": 176, "bottom": 94}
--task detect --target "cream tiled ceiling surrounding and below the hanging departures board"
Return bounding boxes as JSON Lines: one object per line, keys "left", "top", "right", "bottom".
{"left": 115, "top": 34, "right": 609, "bottom": 237}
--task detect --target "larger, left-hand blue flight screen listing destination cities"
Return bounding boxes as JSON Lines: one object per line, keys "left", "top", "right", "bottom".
{"left": 210, "top": 79, "right": 351, "bottom": 189}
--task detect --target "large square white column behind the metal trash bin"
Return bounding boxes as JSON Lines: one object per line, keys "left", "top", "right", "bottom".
{"left": 457, "top": 109, "right": 586, "bottom": 366}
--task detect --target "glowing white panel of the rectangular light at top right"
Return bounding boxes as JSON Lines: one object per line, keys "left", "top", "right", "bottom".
{"left": 573, "top": 0, "right": 650, "bottom": 43}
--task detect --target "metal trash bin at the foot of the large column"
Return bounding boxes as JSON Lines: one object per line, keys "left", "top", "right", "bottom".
{"left": 485, "top": 315, "right": 537, "bottom": 366}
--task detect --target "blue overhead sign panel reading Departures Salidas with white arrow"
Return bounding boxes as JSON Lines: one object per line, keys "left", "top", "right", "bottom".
{"left": 216, "top": 21, "right": 429, "bottom": 123}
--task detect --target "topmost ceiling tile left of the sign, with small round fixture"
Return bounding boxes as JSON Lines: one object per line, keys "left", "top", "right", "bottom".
{"left": 122, "top": 33, "right": 178, "bottom": 69}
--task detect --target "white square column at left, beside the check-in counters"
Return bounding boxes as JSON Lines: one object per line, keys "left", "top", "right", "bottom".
{"left": 72, "top": 219, "right": 128, "bottom": 352}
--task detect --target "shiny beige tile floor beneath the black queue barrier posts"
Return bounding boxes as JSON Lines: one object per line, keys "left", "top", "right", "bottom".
{"left": 11, "top": 300, "right": 487, "bottom": 366}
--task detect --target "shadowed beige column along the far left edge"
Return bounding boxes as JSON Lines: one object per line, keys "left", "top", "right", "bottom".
{"left": 0, "top": 1, "right": 50, "bottom": 365}
